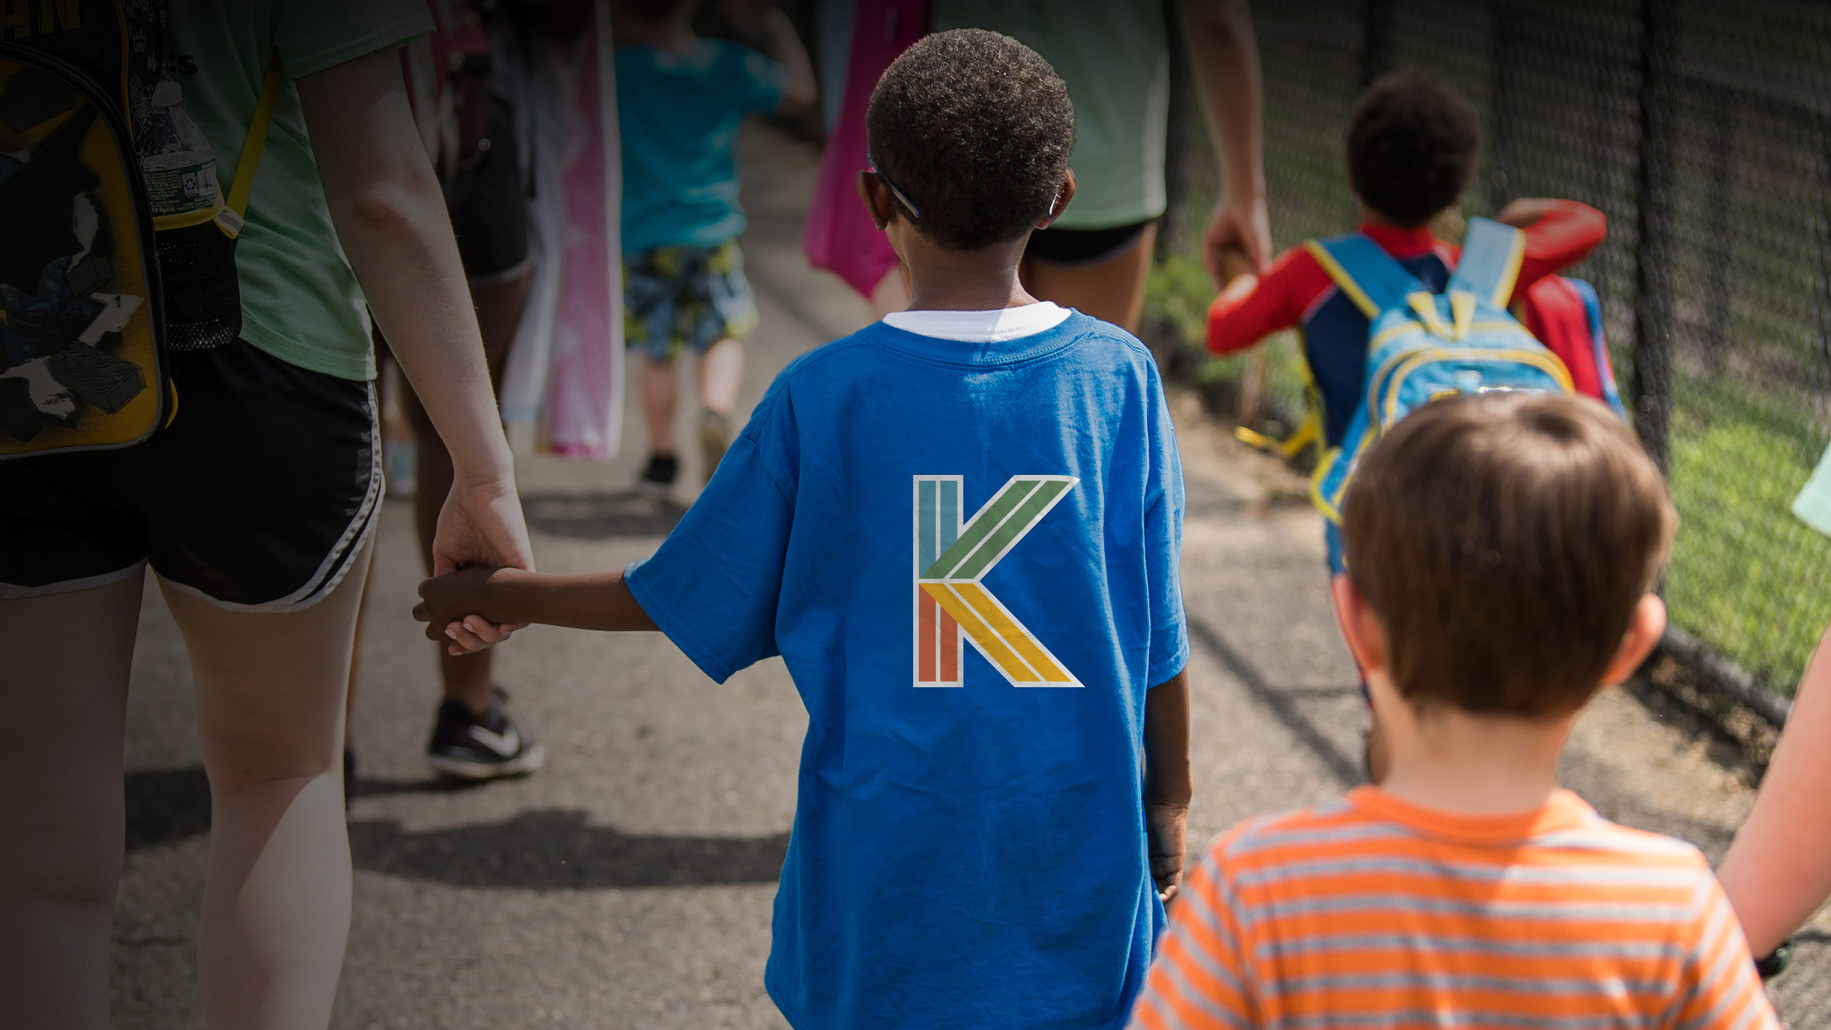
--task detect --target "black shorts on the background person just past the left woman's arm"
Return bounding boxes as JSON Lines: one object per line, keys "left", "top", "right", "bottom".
{"left": 445, "top": 97, "right": 529, "bottom": 282}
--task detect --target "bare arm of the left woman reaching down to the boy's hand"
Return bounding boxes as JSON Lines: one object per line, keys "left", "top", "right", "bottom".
{"left": 298, "top": 49, "right": 533, "bottom": 589}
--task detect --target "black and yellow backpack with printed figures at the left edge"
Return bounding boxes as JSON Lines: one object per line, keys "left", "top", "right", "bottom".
{"left": 0, "top": 0, "right": 284, "bottom": 461}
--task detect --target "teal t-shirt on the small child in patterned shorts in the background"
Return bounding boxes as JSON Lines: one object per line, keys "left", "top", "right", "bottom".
{"left": 615, "top": 40, "right": 784, "bottom": 254}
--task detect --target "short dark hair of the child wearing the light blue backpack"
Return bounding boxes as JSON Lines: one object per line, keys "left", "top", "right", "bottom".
{"left": 1348, "top": 70, "right": 1481, "bottom": 229}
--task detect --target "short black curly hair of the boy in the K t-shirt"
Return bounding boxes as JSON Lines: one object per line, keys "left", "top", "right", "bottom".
{"left": 864, "top": 29, "right": 1075, "bottom": 251}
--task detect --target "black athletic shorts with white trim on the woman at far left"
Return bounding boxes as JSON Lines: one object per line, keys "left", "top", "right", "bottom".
{"left": 0, "top": 340, "right": 381, "bottom": 611}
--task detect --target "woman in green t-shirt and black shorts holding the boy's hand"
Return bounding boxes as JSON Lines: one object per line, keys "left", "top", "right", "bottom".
{"left": 0, "top": 0, "right": 531, "bottom": 1030}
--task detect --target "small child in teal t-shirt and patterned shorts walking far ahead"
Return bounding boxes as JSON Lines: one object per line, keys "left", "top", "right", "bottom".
{"left": 615, "top": 0, "right": 815, "bottom": 498}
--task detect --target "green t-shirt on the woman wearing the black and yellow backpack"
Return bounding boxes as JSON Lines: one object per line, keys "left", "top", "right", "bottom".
{"left": 167, "top": 0, "right": 432, "bottom": 381}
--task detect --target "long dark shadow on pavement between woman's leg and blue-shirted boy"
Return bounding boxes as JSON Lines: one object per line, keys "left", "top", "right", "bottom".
{"left": 350, "top": 809, "right": 789, "bottom": 891}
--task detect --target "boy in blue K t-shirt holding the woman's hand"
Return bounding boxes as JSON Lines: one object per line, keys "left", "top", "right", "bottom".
{"left": 416, "top": 29, "right": 1190, "bottom": 1030}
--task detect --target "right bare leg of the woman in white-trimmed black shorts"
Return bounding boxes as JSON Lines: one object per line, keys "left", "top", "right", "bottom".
{"left": 161, "top": 540, "right": 374, "bottom": 1030}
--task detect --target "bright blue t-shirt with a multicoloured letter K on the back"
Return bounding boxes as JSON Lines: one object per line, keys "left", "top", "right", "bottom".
{"left": 628, "top": 313, "right": 1188, "bottom": 1030}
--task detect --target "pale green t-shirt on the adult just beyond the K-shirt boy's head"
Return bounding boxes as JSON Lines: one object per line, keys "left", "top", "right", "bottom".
{"left": 930, "top": 0, "right": 1170, "bottom": 229}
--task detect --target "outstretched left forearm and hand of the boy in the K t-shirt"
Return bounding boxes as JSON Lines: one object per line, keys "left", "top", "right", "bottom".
{"left": 414, "top": 565, "right": 655, "bottom": 640}
